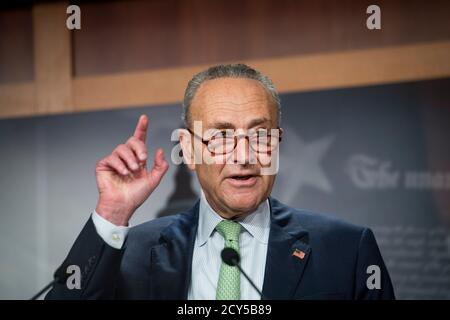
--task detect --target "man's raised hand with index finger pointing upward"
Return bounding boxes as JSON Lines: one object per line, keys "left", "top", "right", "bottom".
{"left": 95, "top": 115, "right": 169, "bottom": 226}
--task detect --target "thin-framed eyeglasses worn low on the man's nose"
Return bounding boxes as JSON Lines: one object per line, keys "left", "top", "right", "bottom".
{"left": 187, "top": 128, "right": 283, "bottom": 156}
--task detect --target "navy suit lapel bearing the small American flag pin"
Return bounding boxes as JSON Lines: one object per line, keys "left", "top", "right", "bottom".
{"left": 263, "top": 198, "right": 311, "bottom": 299}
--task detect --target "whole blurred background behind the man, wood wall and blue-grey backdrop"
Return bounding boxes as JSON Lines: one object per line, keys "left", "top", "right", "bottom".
{"left": 0, "top": 0, "right": 450, "bottom": 299}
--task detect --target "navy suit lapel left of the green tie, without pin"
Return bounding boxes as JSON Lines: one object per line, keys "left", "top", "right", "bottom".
{"left": 150, "top": 202, "right": 199, "bottom": 299}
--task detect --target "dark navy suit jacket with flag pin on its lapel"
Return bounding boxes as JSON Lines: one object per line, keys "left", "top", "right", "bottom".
{"left": 46, "top": 198, "right": 395, "bottom": 299}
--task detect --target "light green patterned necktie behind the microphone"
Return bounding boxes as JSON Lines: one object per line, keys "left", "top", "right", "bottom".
{"left": 216, "top": 220, "right": 241, "bottom": 300}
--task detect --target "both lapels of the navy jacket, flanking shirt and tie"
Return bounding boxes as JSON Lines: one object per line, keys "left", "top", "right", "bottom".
{"left": 150, "top": 198, "right": 311, "bottom": 299}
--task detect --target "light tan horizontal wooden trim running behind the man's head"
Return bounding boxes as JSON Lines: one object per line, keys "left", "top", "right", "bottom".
{"left": 74, "top": 41, "right": 450, "bottom": 111}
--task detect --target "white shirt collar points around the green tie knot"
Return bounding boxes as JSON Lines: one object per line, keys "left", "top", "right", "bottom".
{"left": 197, "top": 190, "right": 270, "bottom": 247}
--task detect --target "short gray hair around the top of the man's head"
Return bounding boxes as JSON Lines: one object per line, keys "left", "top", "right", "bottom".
{"left": 181, "top": 63, "right": 281, "bottom": 127}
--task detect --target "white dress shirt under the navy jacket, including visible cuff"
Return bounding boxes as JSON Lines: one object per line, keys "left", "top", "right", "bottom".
{"left": 92, "top": 191, "right": 270, "bottom": 300}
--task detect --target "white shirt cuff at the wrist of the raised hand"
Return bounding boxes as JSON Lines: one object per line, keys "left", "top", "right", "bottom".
{"left": 92, "top": 210, "right": 130, "bottom": 249}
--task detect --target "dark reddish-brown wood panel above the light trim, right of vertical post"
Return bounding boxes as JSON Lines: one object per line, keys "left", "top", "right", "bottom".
{"left": 74, "top": 0, "right": 450, "bottom": 76}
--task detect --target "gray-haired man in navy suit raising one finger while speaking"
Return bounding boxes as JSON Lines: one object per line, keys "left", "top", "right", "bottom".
{"left": 47, "top": 64, "right": 394, "bottom": 299}
